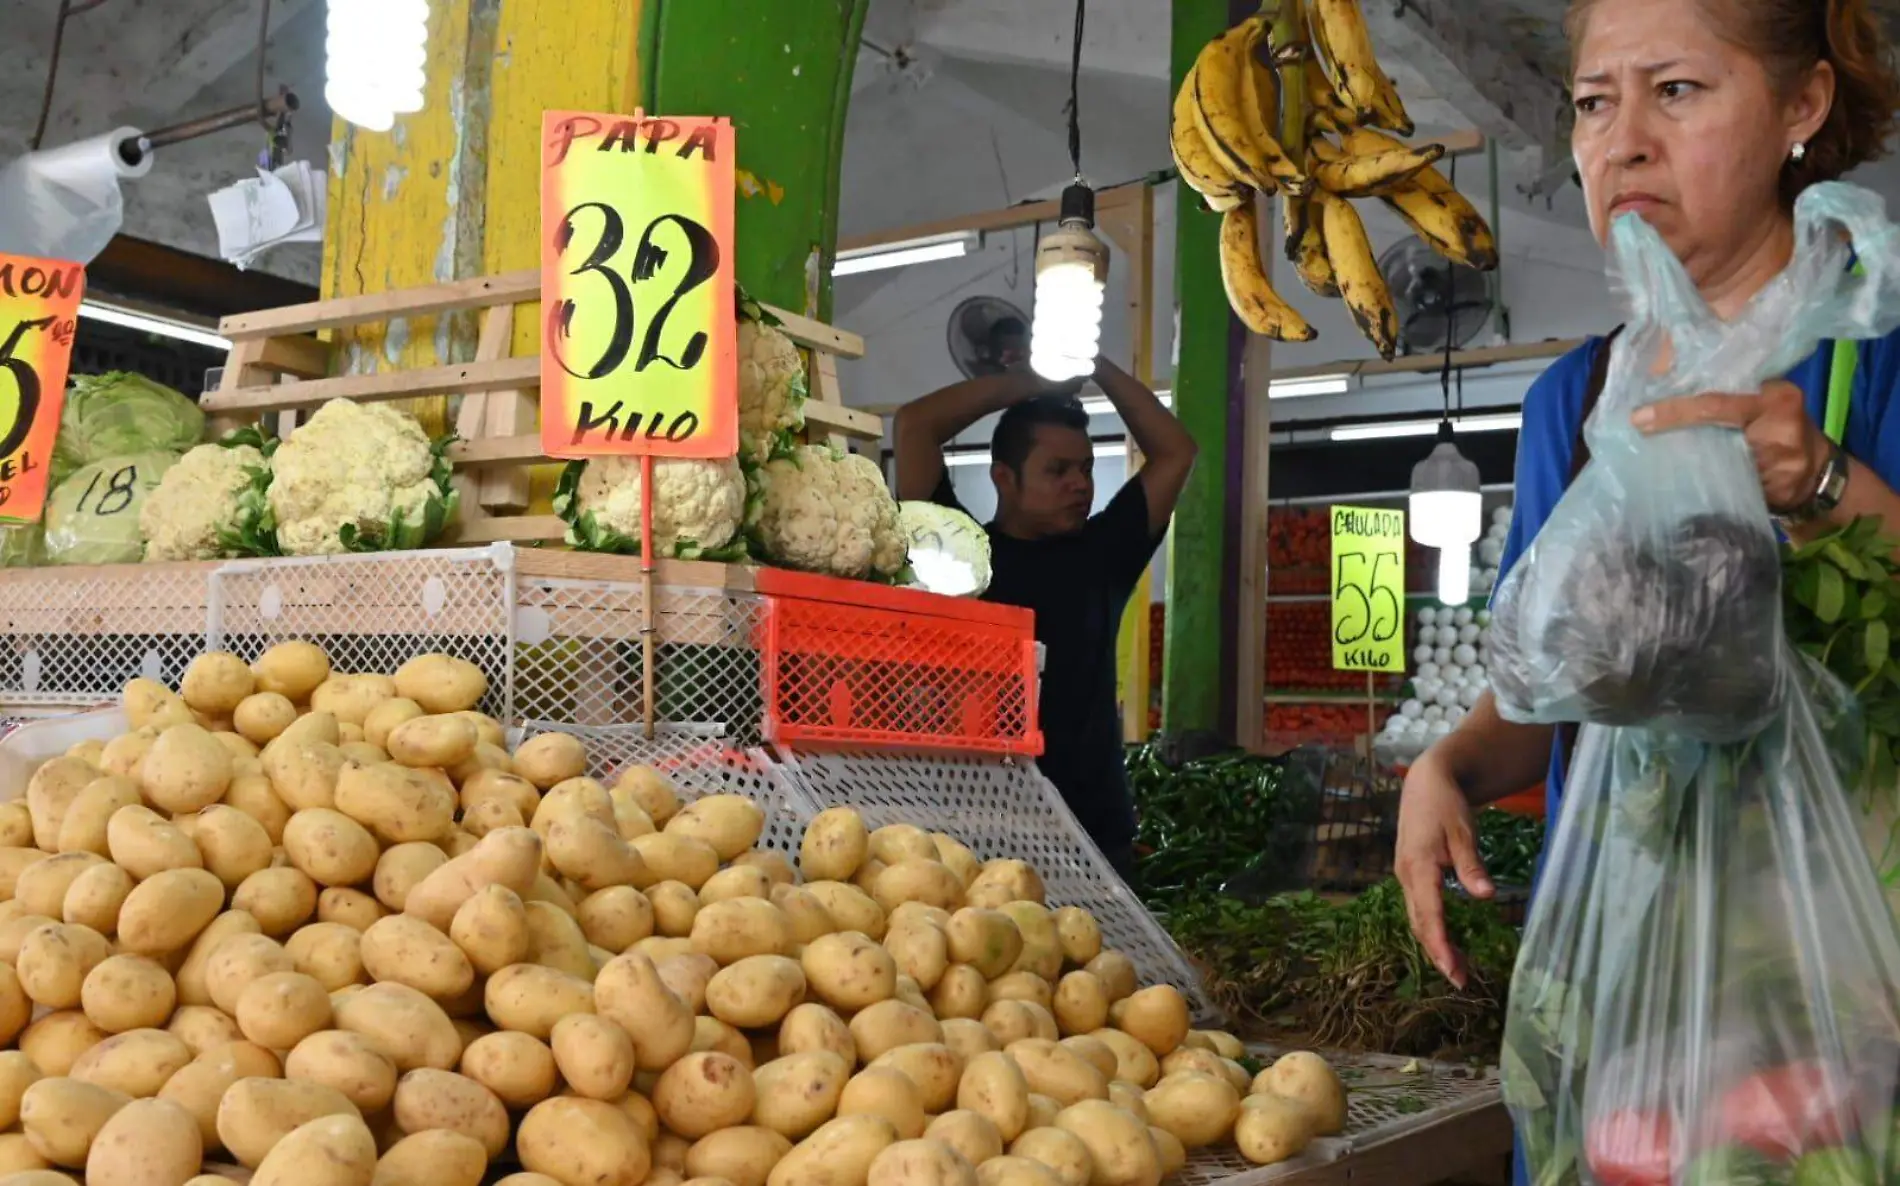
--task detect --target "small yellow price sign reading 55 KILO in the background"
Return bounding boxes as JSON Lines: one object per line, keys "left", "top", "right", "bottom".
{"left": 1332, "top": 506, "right": 1406, "bottom": 673}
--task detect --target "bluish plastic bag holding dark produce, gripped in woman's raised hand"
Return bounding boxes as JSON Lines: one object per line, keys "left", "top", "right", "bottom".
{"left": 1490, "top": 182, "right": 1900, "bottom": 741}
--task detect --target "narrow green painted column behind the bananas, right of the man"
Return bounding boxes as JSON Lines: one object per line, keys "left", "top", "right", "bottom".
{"left": 1161, "top": 0, "right": 1260, "bottom": 737}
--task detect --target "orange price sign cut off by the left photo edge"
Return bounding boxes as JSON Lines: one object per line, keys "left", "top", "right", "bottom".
{"left": 0, "top": 253, "right": 86, "bottom": 523}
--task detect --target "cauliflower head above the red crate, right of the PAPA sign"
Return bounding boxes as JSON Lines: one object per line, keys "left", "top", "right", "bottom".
{"left": 752, "top": 445, "right": 906, "bottom": 580}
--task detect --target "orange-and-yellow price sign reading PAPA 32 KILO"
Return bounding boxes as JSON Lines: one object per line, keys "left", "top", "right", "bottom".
{"left": 542, "top": 112, "right": 739, "bottom": 458}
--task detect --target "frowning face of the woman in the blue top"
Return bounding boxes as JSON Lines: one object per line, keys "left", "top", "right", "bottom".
{"left": 1571, "top": 0, "right": 1832, "bottom": 281}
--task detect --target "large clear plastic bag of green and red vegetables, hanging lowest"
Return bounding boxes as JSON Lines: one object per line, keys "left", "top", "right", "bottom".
{"left": 1503, "top": 650, "right": 1900, "bottom": 1186}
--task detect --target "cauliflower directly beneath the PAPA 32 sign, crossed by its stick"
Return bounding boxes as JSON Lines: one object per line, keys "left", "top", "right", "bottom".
{"left": 555, "top": 458, "right": 745, "bottom": 561}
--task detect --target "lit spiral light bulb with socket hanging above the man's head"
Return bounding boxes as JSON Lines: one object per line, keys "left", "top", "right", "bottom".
{"left": 1030, "top": 177, "right": 1108, "bottom": 382}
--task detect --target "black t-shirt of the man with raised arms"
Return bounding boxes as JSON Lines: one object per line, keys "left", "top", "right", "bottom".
{"left": 931, "top": 475, "right": 1161, "bottom": 855}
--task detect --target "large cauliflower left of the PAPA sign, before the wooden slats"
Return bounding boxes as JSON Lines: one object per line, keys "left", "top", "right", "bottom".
{"left": 270, "top": 399, "right": 456, "bottom": 555}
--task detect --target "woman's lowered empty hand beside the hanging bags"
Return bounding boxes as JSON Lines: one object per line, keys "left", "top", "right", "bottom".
{"left": 1393, "top": 751, "right": 1493, "bottom": 988}
